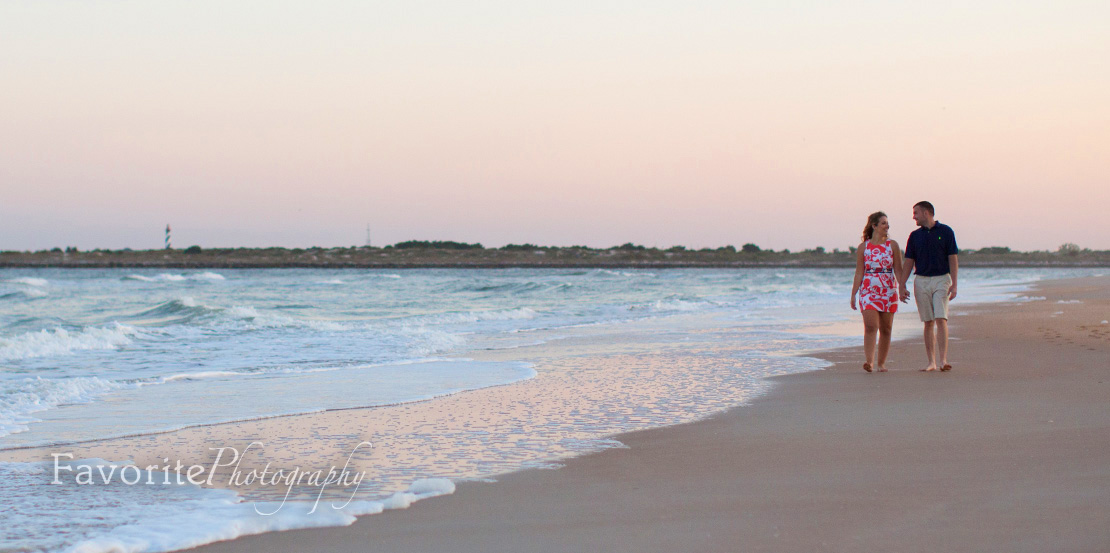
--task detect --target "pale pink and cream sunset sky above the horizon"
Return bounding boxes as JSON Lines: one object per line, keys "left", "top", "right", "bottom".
{"left": 0, "top": 0, "right": 1110, "bottom": 250}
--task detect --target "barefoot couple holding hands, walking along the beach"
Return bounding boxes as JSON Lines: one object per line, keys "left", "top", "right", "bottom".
{"left": 851, "top": 202, "right": 959, "bottom": 372}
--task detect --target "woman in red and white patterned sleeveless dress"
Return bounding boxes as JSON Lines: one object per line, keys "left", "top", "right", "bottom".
{"left": 851, "top": 211, "right": 902, "bottom": 372}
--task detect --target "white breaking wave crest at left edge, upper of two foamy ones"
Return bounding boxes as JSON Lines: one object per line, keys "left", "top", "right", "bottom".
{"left": 0, "top": 323, "right": 139, "bottom": 360}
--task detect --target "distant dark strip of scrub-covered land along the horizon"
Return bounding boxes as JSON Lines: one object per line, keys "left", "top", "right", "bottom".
{"left": 0, "top": 244, "right": 1110, "bottom": 269}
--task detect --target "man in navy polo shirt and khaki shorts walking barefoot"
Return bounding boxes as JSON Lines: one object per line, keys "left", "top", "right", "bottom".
{"left": 898, "top": 202, "right": 959, "bottom": 371}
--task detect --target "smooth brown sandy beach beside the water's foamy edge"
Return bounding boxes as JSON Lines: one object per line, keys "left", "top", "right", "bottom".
{"left": 190, "top": 277, "right": 1110, "bottom": 553}
